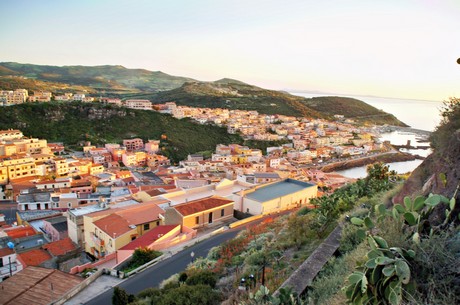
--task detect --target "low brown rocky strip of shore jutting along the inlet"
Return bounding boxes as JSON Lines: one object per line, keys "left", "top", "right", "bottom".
{"left": 320, "top": 152, "right": 425, "bottom": 173}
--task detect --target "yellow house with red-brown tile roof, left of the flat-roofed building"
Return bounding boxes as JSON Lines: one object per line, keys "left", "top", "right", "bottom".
{"left": 165, "top": 196, "right": 234, "bottom": 229}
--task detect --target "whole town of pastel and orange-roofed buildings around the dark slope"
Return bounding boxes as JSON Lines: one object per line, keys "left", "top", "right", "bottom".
{"left": 0, "top": 89, "right": 387, "bottom": 302}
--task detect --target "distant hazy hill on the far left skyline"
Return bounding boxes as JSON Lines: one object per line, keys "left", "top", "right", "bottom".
{"left": 0, "top": 62, "right": 196, "bottom": 93}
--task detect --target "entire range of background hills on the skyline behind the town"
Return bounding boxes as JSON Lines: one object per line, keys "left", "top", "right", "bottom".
{"left": 0, "top": 62, "right": 406, "bottom": 126}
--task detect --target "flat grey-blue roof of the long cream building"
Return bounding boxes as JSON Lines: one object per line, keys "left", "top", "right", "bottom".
{"left": 245, "top": 179, "right": 314, "bottom": 202}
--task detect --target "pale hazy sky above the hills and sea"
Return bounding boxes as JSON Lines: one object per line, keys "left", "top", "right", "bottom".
{"left": 0, "top": 0, "right": 460, "bottom": 101}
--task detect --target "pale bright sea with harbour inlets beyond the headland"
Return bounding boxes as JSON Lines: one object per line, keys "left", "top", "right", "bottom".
{"left": 290, "top": 92, "right": 443, "bottom": 178}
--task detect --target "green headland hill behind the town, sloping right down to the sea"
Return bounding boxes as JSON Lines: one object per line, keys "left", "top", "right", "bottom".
{"left": 144, "top": 79, "right": 407, "bottom": 126}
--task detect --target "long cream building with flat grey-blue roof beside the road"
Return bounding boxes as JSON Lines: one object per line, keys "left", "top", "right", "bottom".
{"left": 233, "top": 178, "right": 318, "bottom": 215}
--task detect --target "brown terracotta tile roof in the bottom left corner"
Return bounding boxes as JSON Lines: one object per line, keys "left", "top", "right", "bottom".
{"left": 0, "top": 267, "right": 84, "bottom": 305}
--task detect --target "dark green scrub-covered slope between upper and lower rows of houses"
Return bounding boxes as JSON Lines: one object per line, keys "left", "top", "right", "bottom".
{"left": 0, "top": 102, "right": 242, "bottom": 162}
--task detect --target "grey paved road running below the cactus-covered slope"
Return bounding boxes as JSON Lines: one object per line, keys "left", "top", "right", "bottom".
{"left": 86, "top": 226, "right": 246, "bottom": 305}
